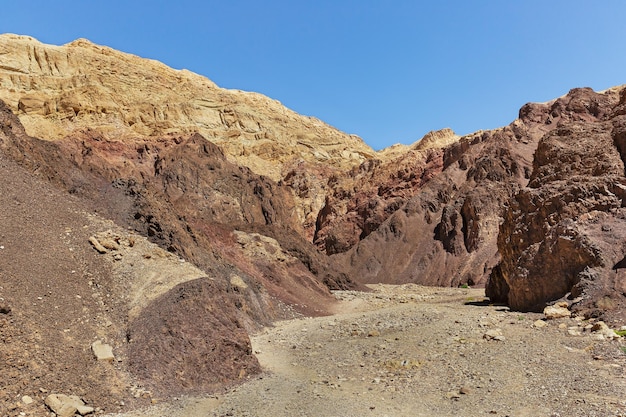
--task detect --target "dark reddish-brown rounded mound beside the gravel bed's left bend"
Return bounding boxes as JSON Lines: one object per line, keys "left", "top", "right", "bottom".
{"left": 128, "top": 278, "right": 260, "bottom": 397}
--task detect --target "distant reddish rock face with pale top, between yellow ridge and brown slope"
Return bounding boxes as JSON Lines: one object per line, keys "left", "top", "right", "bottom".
{"left": 313, "top": 129, "right": 458, "bottom": 255}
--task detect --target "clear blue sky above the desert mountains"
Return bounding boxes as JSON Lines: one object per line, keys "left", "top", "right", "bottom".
{"left": 0, "top": 0, "right": 626, "bottom": 149}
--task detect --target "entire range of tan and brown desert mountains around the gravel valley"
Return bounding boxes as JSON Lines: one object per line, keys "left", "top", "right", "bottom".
{"left": 0, "top": 35, "right": 626, "bottom": 415}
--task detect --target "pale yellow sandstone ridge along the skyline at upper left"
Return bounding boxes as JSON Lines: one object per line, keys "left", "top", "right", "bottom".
{"left": 0, "top": 34, "right": 375, "bottom": 180}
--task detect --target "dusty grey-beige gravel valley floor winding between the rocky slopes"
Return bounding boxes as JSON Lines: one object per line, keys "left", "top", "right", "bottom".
{"left": 107, "top": 285, "right": 626, "bottom": 417}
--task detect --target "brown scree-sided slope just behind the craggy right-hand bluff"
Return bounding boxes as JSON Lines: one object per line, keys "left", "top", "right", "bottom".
{"left": 336, "top": 123, "right": 536, "bottom": 286}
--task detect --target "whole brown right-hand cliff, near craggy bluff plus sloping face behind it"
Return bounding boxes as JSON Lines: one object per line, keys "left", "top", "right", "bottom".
{"left": 335, "top": 88, "right": 625, "bottom": 320}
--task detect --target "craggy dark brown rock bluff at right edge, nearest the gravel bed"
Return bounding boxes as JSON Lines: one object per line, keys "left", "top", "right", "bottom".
{"left": 487, "top": 89, "right": 626, "bottom": 322}
